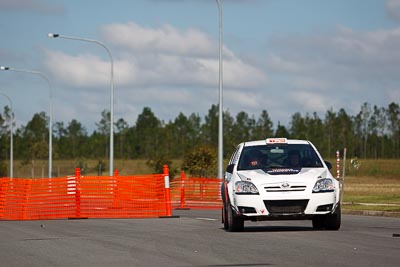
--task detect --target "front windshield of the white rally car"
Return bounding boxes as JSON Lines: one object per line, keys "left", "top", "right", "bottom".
{"left": 237, "top": 144, "right": 323, "bottom": 170}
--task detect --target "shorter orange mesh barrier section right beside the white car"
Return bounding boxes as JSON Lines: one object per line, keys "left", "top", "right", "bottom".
{"left": 171, "top": 172, "right": 222, "bottom": 209}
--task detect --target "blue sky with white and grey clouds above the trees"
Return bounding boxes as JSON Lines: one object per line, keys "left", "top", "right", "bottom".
{"left": 0, "top": 0, "right": 400, "bottom": 132}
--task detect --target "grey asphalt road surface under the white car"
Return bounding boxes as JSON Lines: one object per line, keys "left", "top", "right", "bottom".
{"left": 0, "top": 210, "right": 400, "bottom": 267}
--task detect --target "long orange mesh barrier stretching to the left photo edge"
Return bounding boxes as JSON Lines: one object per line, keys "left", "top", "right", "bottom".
{"left": 0, "top": 169, "right": 171, "bottom": 220}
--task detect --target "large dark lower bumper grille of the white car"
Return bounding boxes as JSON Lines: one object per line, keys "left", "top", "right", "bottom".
{"left": 264, "top": 199, "right": 308, "bottom": 214}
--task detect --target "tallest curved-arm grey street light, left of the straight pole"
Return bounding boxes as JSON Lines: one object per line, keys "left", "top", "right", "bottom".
{"left": 47, "top": 33, "right": 114, "bottom": 176}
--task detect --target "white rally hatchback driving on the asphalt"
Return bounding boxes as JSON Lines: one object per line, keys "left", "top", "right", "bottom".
{"left": 221, "top": 138, "right": 341, "bottom": 231}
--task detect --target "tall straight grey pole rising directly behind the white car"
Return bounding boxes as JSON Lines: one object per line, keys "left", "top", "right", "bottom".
{"left": 216, "top": 0, "right": 224, "bottom": 178}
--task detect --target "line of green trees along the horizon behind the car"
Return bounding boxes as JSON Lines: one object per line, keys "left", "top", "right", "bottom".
{"left": 0, "top": 102, "right": 400, "bottom": 166}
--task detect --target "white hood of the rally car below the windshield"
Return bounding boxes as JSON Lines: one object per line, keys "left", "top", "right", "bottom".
{"left": 237, "top": 168, "right": 332, "bottom": 185}
